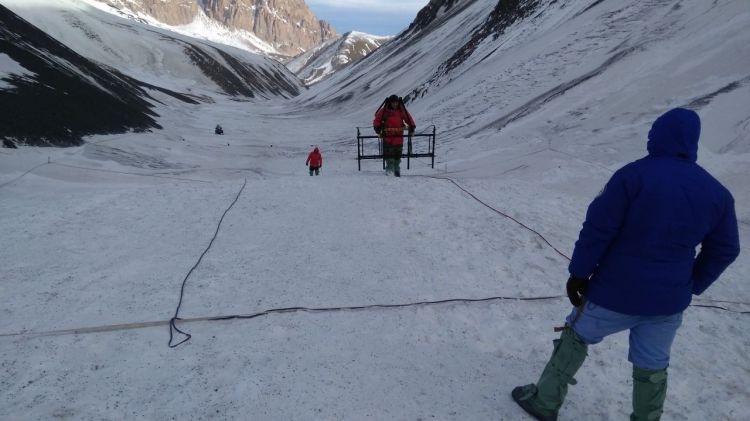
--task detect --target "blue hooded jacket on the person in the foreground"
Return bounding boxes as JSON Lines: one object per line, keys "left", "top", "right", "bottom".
{"left": 569, "top": 108, "right": 740, "bottom": 316}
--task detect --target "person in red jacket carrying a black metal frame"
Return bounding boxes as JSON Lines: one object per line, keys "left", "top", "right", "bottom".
{"left": 372, "top": 95, "right": 417, "bottom": 177}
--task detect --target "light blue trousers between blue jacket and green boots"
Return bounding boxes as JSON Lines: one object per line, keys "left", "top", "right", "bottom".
{"left": 566, "top": 301, "right": 682, "bottom": 370}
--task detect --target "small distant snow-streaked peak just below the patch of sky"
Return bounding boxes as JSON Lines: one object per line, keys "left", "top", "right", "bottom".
{"left": 286, "top": 31, "right": 393, "bottom": 86}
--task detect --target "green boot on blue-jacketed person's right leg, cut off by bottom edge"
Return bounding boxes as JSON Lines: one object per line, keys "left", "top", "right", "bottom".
{"left": 630, "top": 367, "right": 667, "bottom": 421}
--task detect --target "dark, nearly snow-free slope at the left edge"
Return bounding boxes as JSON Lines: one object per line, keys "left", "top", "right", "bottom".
{"left": 0, "top": 5, "right": 169, "bottom": 147}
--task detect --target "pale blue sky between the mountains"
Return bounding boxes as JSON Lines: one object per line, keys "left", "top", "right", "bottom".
{"left": 307, "top": 0, "right": 429, "bottom": 35}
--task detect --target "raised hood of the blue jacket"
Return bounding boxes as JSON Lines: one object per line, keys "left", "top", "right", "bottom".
{"left": 646, "top": 108, "right": 701, "bottom": 162}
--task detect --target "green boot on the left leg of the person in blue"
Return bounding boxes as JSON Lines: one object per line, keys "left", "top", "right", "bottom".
{"left": 511, "top": 326, "right": 588, "bottom": 421}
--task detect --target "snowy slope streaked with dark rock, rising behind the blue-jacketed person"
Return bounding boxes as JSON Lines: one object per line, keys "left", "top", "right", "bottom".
{"left": 295, "top": 0, "right": 750, "bottom": 205}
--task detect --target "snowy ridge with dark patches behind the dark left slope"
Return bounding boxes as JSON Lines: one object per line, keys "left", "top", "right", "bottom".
{"left": 3, "top": 0, "right": 301, "bottom": 98}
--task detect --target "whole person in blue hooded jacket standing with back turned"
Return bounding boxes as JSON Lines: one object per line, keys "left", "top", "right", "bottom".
{"left": 511, "top": 108, "right": 740, "bottom": 421}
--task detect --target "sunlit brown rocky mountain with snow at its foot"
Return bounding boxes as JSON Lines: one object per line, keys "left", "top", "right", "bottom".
{"left": 88, "top": 0, "right": 336, "bottom": 57}
